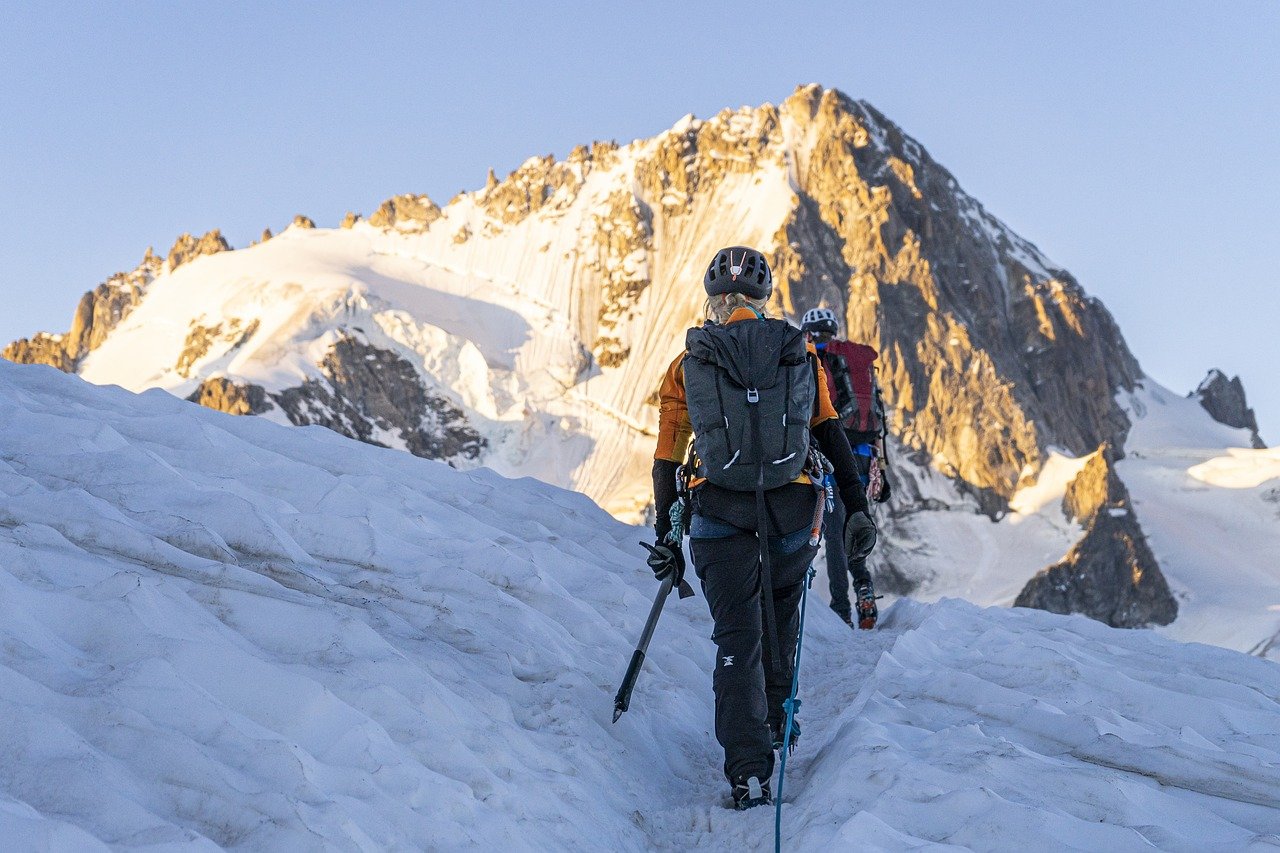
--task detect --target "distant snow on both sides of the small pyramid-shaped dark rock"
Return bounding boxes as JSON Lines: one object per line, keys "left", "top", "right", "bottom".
{"left": 819, "top": 379, "right": 1280, "bottom": 661}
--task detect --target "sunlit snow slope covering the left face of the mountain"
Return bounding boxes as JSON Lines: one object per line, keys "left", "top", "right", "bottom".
{"left": 79, "top": 144, "right": 795, "bottom": 519}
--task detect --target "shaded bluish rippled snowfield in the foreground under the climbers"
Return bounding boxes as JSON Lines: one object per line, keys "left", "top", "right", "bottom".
{"left": 0, "top": 361, "right": 1280, "bottom": 850}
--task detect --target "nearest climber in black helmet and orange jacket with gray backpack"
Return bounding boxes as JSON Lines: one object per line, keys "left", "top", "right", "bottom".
{"left": 649, "top": 246, "right": 876, "bottom": 808}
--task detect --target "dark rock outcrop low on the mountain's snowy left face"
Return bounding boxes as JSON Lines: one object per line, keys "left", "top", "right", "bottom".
{"left": 271, "top": 336, "right": 486, "bottom": 461}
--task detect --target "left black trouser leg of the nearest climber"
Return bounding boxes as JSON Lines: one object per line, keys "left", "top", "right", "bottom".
{"left": 690, "top": 532, "right": 773, "bottom": 783}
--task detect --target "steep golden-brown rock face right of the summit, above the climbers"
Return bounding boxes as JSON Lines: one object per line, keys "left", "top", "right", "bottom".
{"left": 758, "top": 85, "right": 1142, "bottom": 502}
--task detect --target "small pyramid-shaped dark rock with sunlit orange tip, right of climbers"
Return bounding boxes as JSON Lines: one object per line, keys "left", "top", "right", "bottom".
{"left": 1014, "top": 447, "right": 1178, "bottom": 628}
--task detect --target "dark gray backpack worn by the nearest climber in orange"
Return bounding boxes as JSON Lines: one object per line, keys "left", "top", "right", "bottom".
{"left": 684, "top": 320, "right": 817, "bottom": 492}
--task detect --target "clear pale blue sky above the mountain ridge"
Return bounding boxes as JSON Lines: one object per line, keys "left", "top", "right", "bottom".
{"left": 0, "top": 0, "right": 1280, "bottom": 442}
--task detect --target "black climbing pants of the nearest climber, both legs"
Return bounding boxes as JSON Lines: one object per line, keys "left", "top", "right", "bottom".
{"left": 690, "top": 516, "right": 818, "bottom": 783}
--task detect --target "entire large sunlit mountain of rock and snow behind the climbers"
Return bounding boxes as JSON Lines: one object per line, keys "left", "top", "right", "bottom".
{"left": 5, "top": 86, "right": 1269, "bottom": 624}
